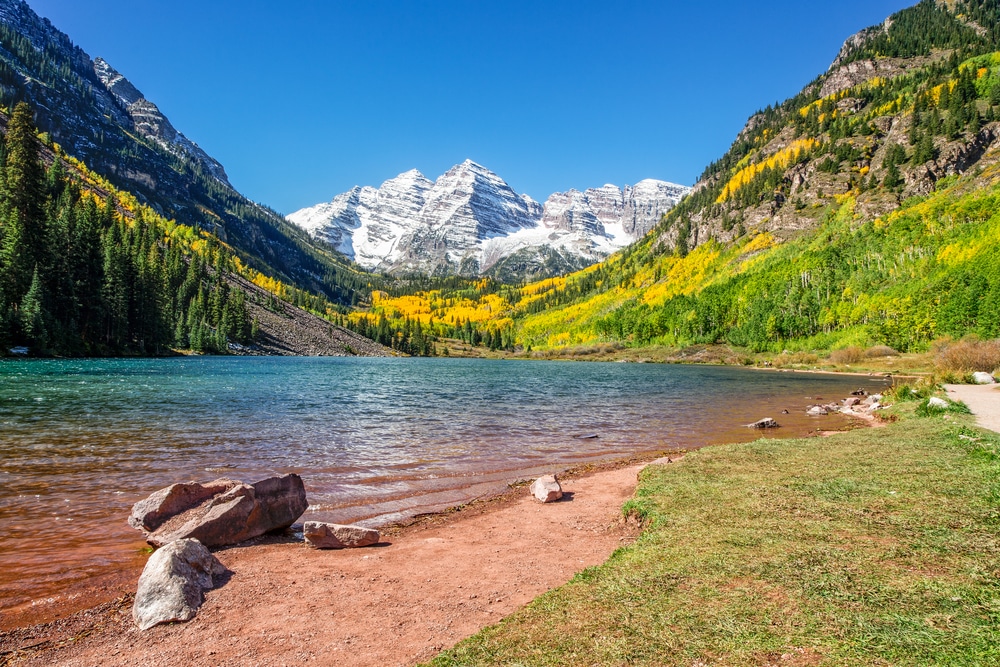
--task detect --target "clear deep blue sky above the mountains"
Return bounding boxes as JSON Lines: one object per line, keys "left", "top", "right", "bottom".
{"left": 28, "top": 0, "right": 916, "bottom": 213}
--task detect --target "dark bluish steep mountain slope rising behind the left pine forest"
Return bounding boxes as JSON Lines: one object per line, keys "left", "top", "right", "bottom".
{"left": 0, "top": 0, "right": 370, "bottom": 303}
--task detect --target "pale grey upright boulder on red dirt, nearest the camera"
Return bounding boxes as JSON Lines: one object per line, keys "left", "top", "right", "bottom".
{"left": 132, "top": 539, "right": 227, "bottom": 630}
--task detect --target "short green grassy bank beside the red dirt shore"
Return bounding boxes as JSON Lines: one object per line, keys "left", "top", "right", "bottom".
{"left": 432, "top": 401, "right": 1000, "bottom": 667}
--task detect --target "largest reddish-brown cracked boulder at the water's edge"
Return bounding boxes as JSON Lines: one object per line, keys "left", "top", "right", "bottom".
{"left": 129, "top": 474, "right": 308, "bottom": 547}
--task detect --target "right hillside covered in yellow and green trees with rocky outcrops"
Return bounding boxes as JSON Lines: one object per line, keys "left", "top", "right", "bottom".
{"left": 364, "top": 0, "right": 1000, "bottom": 360}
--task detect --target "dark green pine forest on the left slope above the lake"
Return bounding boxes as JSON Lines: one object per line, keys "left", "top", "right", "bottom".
{"left": 0, "top": 103, "right": 378, "bottom": 356}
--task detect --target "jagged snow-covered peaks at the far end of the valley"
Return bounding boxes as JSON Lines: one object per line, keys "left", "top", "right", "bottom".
{"left": 288, "top": 160, "right": 688, "bottom": 278}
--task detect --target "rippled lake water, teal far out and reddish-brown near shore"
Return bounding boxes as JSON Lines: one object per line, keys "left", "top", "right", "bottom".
{"left": 0, "top": 357, "right": 884, "bottom": 621}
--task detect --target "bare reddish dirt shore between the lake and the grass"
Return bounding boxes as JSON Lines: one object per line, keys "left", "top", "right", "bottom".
{"left": 0, "top": 466, "right": 639, "bottom": 667}
